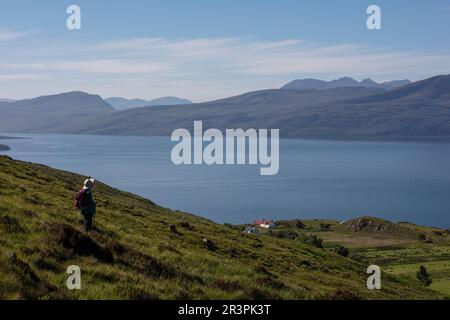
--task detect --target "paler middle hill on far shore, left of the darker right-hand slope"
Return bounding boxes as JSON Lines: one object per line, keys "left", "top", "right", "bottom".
{"left": 59, "top": 87, "right": 385, "bottom": 136}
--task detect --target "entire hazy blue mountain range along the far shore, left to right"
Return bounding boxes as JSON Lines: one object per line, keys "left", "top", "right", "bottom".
{"left": 0, "top": 75, "right": 450, "bottom": 140}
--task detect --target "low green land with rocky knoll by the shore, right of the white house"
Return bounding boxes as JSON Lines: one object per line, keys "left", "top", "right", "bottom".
{"left": 271, "top": 217, "right": 450, "bottom": 298}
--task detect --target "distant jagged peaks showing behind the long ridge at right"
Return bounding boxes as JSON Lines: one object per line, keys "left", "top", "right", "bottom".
{"left": 281, "top": 77, "right": 411, "bottom": 90}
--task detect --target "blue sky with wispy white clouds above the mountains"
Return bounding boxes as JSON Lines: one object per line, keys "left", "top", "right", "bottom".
{"left": 0, "top": 0, "right": 450, "bottom": 102}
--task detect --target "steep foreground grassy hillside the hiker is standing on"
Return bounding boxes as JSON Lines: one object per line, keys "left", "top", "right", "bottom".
{"left": 0, "top": 156, "right": 442, "bottom": 299}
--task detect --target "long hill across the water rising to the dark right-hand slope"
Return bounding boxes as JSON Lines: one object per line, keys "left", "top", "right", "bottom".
{"left": 57, "top": 76, "right": 450, "bottom": 140}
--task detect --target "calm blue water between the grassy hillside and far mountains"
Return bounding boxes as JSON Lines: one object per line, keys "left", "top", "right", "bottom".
{"left": 2, "top": 135, "right": 450, "bottom": 227}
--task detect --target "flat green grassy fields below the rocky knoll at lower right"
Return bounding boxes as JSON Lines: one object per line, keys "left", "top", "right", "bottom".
{"left": 282, "top": 218, "right": 450, "bottom": 297}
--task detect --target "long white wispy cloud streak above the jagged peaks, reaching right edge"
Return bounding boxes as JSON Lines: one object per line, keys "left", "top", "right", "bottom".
{"left": 91, "top": 38, "right": 450, "bottom": 76}
